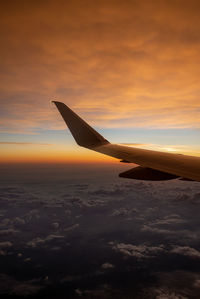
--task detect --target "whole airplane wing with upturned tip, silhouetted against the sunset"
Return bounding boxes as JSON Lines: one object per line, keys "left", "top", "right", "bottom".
{"left": 53, "top": 101, "right": 200, "bottom": 181}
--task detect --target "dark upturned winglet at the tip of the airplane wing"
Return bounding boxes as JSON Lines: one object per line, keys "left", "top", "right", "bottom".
{"left": 52, "top": 101, "right": 109, "bottom": 148}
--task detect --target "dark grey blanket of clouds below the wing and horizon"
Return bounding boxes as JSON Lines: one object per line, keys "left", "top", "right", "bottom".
{"left": 0, "top": 165, "right": 200, "bottom": 299}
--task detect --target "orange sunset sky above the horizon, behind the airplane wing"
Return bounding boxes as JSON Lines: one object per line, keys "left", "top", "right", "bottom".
{"left": 0, "top": 0, "right": 200, "bottom": 163}
